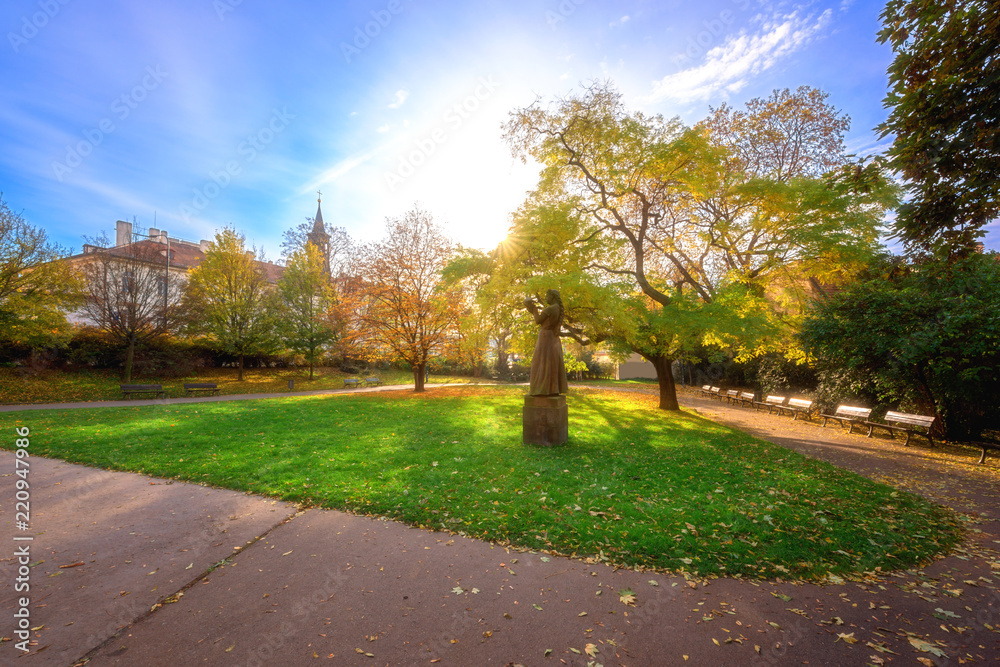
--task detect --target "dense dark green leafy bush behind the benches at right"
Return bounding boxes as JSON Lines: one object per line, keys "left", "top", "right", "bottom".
{"left": 801, "top": 253, "right": 1000, "bottom": 440}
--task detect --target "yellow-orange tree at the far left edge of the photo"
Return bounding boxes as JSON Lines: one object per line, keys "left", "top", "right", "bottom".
{"left": 0, "top": 196, "right": 81, "bottom": 349}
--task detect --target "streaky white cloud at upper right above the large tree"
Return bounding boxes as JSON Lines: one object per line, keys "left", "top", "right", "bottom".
{"left": 644, "top": 9, "right": 832, "bottom": 103}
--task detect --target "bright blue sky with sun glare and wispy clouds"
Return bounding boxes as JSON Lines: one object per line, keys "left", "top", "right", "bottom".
{"left": 0, "top": 0, "right": 1000, "bottom": 259}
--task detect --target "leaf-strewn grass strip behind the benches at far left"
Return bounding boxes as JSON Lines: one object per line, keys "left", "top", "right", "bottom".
{"left": 0, "top": 368, "right": 489, "bottom": 405}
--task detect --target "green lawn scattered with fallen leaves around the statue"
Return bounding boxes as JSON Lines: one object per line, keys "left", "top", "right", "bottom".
{"left": 3, "top": 387, "right": 961, "bottom": 578}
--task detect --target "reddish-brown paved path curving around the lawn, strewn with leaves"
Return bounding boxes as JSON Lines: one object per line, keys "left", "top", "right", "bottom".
{"left": 0, "top": 388, "right": 1000, "bottom": 667}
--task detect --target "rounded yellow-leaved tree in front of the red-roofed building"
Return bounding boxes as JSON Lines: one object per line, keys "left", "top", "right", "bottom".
{"left": 185, "top": 227, "right": 277, "bottom": 382}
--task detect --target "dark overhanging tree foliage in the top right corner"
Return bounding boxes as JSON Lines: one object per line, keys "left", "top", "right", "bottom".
{"left": 878, "top": 0, "right": 1000, "bottom": 255}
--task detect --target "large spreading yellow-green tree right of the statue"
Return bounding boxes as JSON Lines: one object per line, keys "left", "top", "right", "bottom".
{"left": 506, "top": 84, "right": 891, "bottom": 410}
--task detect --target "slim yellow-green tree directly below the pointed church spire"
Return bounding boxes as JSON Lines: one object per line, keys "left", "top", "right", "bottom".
{"left": 278, "top": 243, "right": 338, "bottom": 380}
